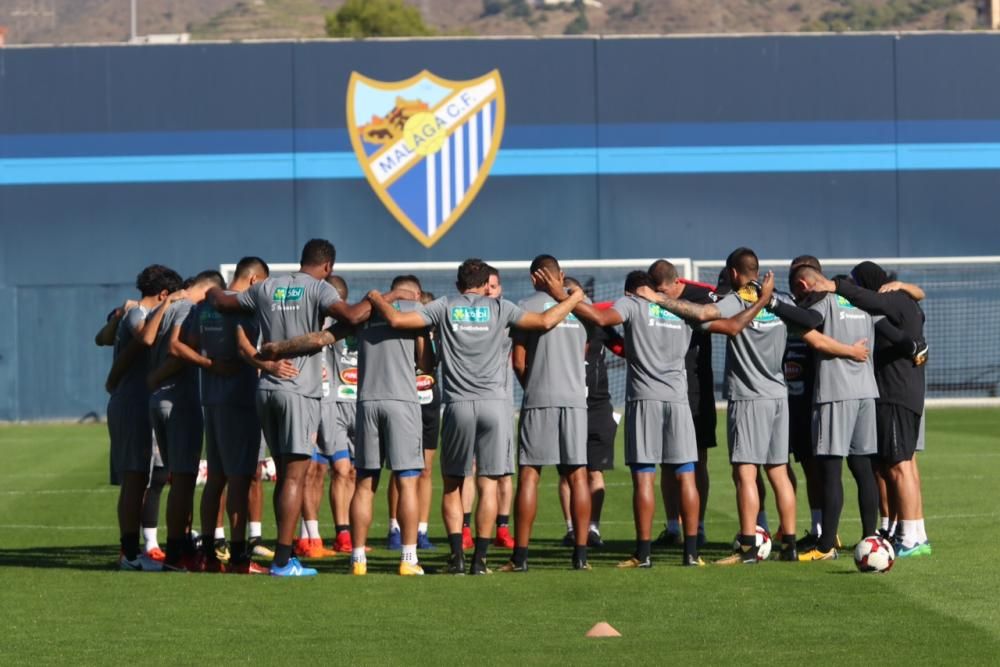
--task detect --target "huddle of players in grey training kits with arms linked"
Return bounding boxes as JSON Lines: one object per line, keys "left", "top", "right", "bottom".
{"left": 97, "top": 239, "right": 931, "bottom": 576}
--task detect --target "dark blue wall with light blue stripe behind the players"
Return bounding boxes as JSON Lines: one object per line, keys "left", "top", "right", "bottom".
{"left": 0, "top": 34, "right": 1000, "bottom": 420}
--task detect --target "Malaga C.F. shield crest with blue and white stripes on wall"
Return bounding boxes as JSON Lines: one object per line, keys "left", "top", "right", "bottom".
{"left": 347, "top": 70, "right": 504, "bottom": 248}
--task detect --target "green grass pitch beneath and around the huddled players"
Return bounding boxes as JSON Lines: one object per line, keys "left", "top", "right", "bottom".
{"left": 0, "top": 410, "right": 1000, "bottom": 665}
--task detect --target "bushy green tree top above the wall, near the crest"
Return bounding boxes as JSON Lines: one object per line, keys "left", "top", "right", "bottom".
{"left": 326, "top": 0, "right": 434, "bottom": 39}
